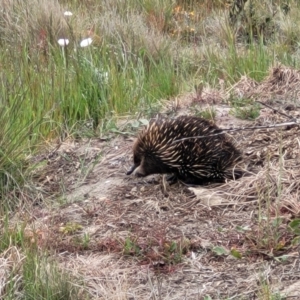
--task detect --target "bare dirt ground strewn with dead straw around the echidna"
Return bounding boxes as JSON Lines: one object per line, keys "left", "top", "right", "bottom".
{"left": 14, "top": 67, "right": 300, "bottom": 299}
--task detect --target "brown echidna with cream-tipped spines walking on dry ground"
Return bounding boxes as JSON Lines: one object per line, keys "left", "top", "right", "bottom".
{"left": 127, "top": 116, "right": 242, "bottom": 184}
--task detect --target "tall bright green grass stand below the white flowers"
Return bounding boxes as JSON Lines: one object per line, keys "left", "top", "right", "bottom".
{"left": 0, "top": 10, "right": 181, "bottom": 207}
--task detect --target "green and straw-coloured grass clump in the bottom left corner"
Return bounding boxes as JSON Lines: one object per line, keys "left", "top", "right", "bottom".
{"left": 0, "top": 218, "right": 88, "bottom": 300}
